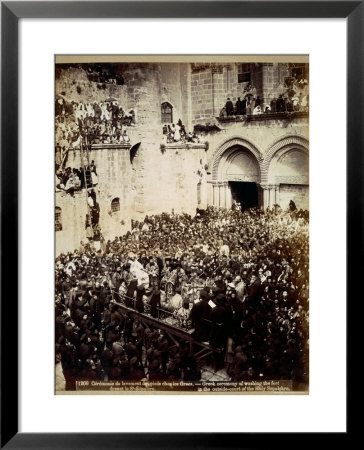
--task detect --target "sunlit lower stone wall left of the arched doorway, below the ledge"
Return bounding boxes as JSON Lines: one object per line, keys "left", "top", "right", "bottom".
{"left": 55, "top": 144, "right": 207, "bottom": 254}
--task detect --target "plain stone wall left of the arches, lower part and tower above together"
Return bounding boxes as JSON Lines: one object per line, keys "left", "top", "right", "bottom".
{"left": 56, "top": 64, "right": 207, "bottom": 254}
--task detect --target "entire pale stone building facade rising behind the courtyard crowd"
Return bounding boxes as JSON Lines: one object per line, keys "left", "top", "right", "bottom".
{"left": 55, "top": 63, "right": 309, "bottom": 254}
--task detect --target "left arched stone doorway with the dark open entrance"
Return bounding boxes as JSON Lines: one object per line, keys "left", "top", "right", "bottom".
{"left": 209, "top": 142, "right": 262, "bottom": 209}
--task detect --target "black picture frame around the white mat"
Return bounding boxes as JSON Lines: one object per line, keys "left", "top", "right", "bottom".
{"left": 1, "top": 0, "right": 356, "bottom": 449}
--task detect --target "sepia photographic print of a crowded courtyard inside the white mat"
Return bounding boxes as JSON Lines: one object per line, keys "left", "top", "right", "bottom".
{"left": 54, "top": 55, "right": 309, "bottom": 395}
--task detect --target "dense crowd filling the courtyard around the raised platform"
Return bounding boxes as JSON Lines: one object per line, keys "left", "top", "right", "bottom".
{"left": 55, "top": 204, "right": 309, "bottom": 389}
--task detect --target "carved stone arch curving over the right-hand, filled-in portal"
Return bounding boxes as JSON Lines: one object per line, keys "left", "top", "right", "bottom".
{"left": 261, "top": 135, "right": 309, "bottom": 183}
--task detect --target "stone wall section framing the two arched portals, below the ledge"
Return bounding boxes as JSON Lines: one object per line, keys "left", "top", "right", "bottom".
{"left": 202, "top": 117, "right": 309, "bottom": 208}
